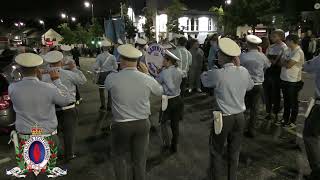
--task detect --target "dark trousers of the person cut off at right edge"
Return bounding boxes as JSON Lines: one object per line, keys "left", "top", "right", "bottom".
{"left": 303, "top": 105, "right": 320, "bottom": 180}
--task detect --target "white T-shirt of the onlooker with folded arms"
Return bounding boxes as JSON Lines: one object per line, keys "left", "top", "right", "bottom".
{"left": 280, "top": 46, "right": 304, "bottom": 82}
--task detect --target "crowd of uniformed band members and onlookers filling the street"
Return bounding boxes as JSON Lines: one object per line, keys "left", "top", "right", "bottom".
{"left": 4, "top": 27, "right": 320, "bottom": 180}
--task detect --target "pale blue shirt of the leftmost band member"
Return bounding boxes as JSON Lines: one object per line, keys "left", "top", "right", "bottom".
{"left": 9, "top": 77, "right": 72, "bottom": 134}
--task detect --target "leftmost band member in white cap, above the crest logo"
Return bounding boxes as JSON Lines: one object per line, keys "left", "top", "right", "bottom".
{"left": 9, "top": 53, "right": 74, "bottom": 156}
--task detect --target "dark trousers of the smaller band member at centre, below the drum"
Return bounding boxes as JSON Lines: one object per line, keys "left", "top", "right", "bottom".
{"left": 160, "top": 96, "right": 183, "bottom": 146}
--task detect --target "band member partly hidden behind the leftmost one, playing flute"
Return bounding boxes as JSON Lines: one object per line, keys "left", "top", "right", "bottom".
{"left": 42, "top": 51, "right": 87, "bottom": 161}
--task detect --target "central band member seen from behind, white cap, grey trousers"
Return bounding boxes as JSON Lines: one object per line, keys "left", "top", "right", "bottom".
{"left": 105, "top": 44, "right": 163, "bottom": 180}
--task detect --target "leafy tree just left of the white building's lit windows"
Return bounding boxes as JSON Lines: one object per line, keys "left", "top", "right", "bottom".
{"left": 166, "top": 0, "right": 187, "bottom": 34}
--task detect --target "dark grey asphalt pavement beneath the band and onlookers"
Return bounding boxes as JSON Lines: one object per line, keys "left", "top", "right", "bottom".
{"left": 0, "top": 58, "right": 314, "bottom": 180}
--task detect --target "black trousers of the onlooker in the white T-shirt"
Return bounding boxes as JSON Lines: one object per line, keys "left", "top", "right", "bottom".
{"left": 281, "top": 81, "right": 302, "bottom": 123}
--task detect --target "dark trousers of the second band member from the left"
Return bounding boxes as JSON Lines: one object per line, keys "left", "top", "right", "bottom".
{"left": 57, "top": 108, "right": 78, "bottom": 160}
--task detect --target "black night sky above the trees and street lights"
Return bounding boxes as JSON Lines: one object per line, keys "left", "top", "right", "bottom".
{"left": 0, "top": 0, "right": 318, "bottom": 28}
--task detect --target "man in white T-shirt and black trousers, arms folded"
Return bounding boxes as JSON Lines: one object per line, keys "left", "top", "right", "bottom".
{"left": 280, "top": 34, "right": 304, "bottom": 127}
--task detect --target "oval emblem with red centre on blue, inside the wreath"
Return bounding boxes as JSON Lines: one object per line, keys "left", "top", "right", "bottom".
{"left": 23, "top": 136, "right": 51, "bottom": 173}
